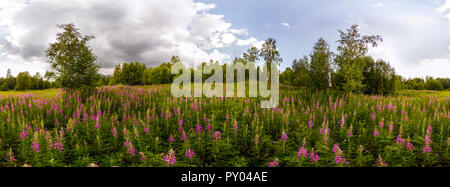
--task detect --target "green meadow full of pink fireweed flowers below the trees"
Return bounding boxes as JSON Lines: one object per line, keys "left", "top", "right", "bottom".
{"left": 0, "top": 86, "right": 450, "bottom": 167}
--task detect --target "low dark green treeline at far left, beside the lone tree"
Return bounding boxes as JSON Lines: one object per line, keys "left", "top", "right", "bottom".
{"left": 0, "top": 69, "right": 57, "bottom": 91}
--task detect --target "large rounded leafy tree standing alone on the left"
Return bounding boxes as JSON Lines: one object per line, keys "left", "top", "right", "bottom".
{"left": 46, "top": 23, "right": 100, "bottom": 93}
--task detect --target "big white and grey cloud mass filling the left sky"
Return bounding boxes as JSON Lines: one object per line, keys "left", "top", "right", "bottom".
{"left": 0, "top": 0, "right": 260, "bottom": 75}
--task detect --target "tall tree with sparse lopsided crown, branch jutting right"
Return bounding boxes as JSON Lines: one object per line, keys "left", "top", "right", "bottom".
{"left": 335, "top": 25, "right": 383, "bottom": 92}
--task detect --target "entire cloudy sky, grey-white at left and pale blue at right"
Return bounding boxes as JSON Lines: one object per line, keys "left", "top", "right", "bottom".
{"left": 0, "top": 0, "right": 450, "bottom": 77}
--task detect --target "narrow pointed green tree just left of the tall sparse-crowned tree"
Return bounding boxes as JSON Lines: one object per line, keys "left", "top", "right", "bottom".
{"left": 309, "top": 38, "right": 332, "bottom": 90}
